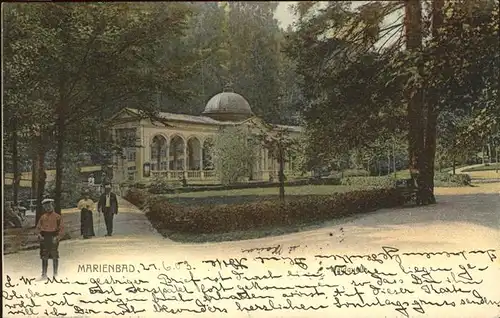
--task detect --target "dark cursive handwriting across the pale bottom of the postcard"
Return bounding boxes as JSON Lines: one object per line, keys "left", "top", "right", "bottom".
{"left": 2, "top": 245, "right": 500, "bottom": 317}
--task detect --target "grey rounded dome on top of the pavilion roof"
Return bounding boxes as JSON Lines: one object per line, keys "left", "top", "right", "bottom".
{"left": 203, "top": 88, "right": 253, "bottom": 121}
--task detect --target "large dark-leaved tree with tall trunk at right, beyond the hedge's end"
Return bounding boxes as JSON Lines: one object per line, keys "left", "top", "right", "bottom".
{"left": 288, "top": 0, "right": 498, "bottom": 204}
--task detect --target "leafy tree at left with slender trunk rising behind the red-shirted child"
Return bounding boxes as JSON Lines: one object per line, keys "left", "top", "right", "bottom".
{"left": 6, "top": 3, "right": 195, "bottom": 219}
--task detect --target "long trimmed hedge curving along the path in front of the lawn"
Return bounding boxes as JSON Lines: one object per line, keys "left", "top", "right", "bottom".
{"left": 146, "top": 189, "right": 404, "bottom": 234}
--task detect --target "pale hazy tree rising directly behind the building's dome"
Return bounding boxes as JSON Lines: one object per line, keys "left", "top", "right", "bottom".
{"left": 162, "top": 1, "right": 298, "bottom": 123}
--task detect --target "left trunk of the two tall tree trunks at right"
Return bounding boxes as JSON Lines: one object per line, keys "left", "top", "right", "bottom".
{"left": 405, "top": 1, "right": 425, "bottom": 204}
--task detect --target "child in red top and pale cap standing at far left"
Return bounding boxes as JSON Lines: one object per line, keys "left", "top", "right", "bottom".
{"left": 37, "top": 199, "right": 64, "bottom": 279}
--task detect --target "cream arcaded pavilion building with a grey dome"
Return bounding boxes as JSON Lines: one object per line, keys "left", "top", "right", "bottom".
{"left": 111, "top": 90, "right": 302, "bottom": 183}
